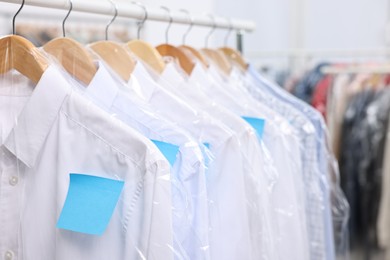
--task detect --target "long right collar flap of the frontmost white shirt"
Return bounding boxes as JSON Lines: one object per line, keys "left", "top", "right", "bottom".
{"left": 4, "top": 66, "right": 71, "bottom": 168}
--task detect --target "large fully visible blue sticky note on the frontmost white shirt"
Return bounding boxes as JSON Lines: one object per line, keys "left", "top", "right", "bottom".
{"left": 57, "top": 173, "right": 124, "bottom": 235}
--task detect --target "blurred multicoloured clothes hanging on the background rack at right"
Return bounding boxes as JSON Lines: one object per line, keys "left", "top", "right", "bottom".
{"left": 270, "top": 64, "right": 390, "bottom": 259}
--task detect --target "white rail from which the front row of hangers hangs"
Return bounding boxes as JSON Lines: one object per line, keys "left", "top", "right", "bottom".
{"left": 0, "top": 0, "right": 255, "bottom": 32}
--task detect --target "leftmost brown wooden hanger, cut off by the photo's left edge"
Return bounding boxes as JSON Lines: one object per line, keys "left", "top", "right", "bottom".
{"left": 0, "top": 35, "right": 49, "bottom": 84}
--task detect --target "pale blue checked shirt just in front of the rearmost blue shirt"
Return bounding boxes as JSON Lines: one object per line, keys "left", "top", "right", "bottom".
{"left": 243, "top": 66, "right": 330, "bottom": 258}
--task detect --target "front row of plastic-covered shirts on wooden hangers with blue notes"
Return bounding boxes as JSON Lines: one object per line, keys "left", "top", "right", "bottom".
{"left": 0, "top": 1, "right": 347, "bottom": 260}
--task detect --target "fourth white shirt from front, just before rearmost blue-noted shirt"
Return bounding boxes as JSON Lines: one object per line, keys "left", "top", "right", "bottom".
{"left": 159, "top": 63, "right": 276, "bottom": 259}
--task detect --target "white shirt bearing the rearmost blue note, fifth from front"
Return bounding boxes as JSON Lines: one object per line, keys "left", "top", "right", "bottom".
{"left": 190, "top": 63, "right": 309, "bottom": 259}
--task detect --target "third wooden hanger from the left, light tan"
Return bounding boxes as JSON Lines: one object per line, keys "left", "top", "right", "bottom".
{"left": 89, "top": 41, "right": 136, "bottom": 82}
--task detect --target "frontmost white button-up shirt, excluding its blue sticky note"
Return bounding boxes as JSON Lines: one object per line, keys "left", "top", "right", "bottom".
{"left": 0, "top": 66, "right": 173, "bottom": 260}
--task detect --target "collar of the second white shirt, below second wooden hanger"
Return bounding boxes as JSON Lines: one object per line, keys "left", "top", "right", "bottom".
{"left": 85, "top": 62, "right": 118, "bottom": 108}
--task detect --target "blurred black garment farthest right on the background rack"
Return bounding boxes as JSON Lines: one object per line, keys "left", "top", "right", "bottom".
{"left": 358, "top": 88, "right": 390, "bottom": 246}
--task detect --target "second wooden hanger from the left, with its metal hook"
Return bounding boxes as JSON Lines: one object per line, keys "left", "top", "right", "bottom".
{"left": 43, "top": 0, "right": 97, "bottom": 85}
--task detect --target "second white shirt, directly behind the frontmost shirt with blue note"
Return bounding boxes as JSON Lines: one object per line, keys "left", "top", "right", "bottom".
{"left": 72, "top": 62, "right": 210, "bottom": 259}
